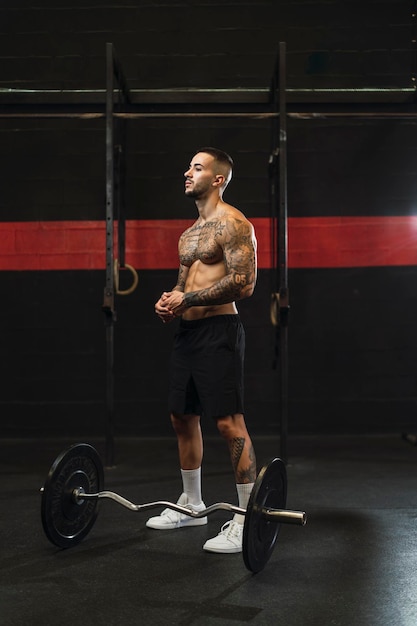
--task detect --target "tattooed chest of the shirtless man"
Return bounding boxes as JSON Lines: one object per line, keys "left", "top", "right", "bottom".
{"left": 179, "top": 222, "right": 224, "bottom": 266}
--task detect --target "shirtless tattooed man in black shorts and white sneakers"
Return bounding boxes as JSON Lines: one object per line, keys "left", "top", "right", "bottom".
{"left": 146, "top": 148, "right": 256, "bottom": 553}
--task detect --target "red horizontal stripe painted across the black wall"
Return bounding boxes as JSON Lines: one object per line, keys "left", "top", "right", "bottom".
{"left": 0, "top": 216, "right": 417, "bottom": 270}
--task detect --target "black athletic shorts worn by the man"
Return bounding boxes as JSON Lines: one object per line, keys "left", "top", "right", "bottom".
{"left": 169, "top": 315, "right": 245, "bottom": 418}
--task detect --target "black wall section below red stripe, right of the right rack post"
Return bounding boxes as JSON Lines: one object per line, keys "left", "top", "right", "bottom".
{"left": 290, "top": 267, "right": 417, "bottom": 432}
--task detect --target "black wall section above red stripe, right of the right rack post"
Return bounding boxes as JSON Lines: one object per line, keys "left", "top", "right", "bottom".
{"left": 288, "top": 118, "right": 417, "bottom": 217}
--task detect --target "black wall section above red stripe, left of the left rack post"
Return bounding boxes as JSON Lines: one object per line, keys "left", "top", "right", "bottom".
{"left": 0, "top": 118, "right": 106, "bottom": 221}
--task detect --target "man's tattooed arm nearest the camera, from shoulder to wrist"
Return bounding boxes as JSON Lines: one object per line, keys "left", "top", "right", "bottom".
{"left": 184, "top": 219, "right": 256, "bottom": 308}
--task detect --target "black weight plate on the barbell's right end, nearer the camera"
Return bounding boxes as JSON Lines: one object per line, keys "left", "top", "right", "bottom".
{"left": 243, "top": 458, "right": 287, "bottom": 573}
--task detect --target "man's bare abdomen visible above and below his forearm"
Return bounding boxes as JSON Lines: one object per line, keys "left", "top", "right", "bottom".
{"left": 182, "top": 261, "right": 238, "bottom": 320}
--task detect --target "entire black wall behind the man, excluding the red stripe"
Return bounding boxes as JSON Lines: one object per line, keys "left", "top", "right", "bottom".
{"left": 0, "top": 0, "right": 417, "bottom": 436}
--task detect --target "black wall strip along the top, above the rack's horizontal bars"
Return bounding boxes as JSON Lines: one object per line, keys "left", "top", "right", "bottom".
{"left": 0, "top": 0, "right": 415, "bottom": 89}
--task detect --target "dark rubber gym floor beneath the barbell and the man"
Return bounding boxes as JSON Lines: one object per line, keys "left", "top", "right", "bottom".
{"left": 0, "top": 434, "right": 417, "bottom": 626}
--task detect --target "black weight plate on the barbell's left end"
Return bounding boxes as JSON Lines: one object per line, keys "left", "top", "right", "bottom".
{"left": 41, "top": 443, "right": 104, "bottom": 548}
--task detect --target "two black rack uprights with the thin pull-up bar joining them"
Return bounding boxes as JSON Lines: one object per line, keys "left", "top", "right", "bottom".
{"left": 103, "top": 43, "right": 289, "bottom": 466}
